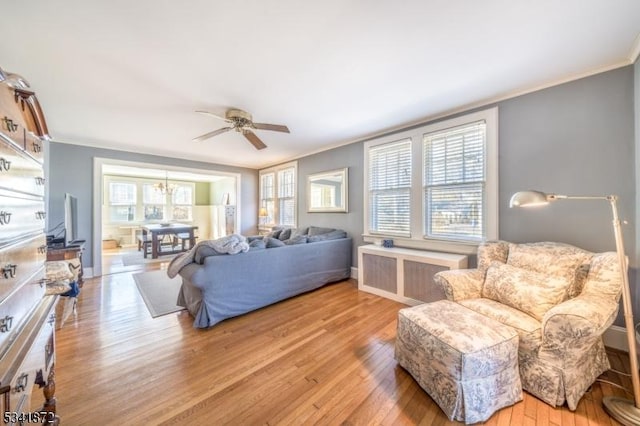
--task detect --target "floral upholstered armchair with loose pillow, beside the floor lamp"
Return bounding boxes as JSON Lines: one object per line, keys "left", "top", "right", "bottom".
{"left": 435, "top": 241, "right": 621, "bottom": 410}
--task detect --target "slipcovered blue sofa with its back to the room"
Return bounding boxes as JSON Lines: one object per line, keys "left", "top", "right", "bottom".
{"left": 178, "top": 227, "right": 352, "bottom": 328}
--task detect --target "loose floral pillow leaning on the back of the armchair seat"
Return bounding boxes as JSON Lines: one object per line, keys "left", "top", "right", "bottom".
{"left": 482, "top": 262, "right": 572, "bottom": 321}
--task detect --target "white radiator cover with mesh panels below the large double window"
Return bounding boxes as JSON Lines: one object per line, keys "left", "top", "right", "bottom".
{"left": 358, "top": 244, "right": 467, "bottom": 305}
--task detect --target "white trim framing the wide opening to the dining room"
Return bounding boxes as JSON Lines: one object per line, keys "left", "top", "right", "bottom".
{"left": 87, "top": 157, "right": 242, "bottom": 276}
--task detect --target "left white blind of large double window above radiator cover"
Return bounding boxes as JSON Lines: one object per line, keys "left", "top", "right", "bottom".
{"left": 368, "top": 139, "right": 411, "bottom": 236}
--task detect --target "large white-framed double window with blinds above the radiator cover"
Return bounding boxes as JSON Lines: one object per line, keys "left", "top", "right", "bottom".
{"left": 364, "top": 108, "right": 498, "bottom": 253}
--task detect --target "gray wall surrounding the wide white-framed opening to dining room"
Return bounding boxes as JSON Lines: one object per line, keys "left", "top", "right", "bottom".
{"left": 47, "top": 142, "right": 258, "bottom": 267}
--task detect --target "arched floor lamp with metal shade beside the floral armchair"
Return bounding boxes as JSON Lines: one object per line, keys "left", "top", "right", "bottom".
{"left": 509, "top": 191, "right": 640, "bottom": 426}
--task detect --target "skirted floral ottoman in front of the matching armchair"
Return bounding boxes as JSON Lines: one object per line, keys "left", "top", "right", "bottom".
{"left": 395, "top": 300, "right": 522, "bottom": 423}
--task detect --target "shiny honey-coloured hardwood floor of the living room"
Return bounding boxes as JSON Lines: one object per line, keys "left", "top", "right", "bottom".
{"left": 56, "top": 266, "right": 631, "bottom": 426}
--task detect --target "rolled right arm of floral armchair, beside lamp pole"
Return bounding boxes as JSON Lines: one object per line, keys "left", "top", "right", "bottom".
{"left": 540, "top": 295, "right": 619, "bottom": 360}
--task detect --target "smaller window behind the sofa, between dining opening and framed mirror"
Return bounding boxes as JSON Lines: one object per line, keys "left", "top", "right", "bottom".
{"left": 260, "top": 162, "right": 298, "bottom": 226}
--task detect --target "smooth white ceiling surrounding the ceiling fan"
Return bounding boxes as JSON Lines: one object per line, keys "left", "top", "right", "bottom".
{"left": 0, "top": 0, "right": 640, "bottom": 168}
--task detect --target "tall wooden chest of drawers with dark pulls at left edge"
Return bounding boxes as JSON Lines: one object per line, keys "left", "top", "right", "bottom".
{"left": 0, "top": 69, "right": 58, "bottom": 424}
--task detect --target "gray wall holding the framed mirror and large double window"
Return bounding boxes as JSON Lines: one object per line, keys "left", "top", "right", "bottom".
{"left": 298, "top": 64, "right": 640, "bottom": 322}
